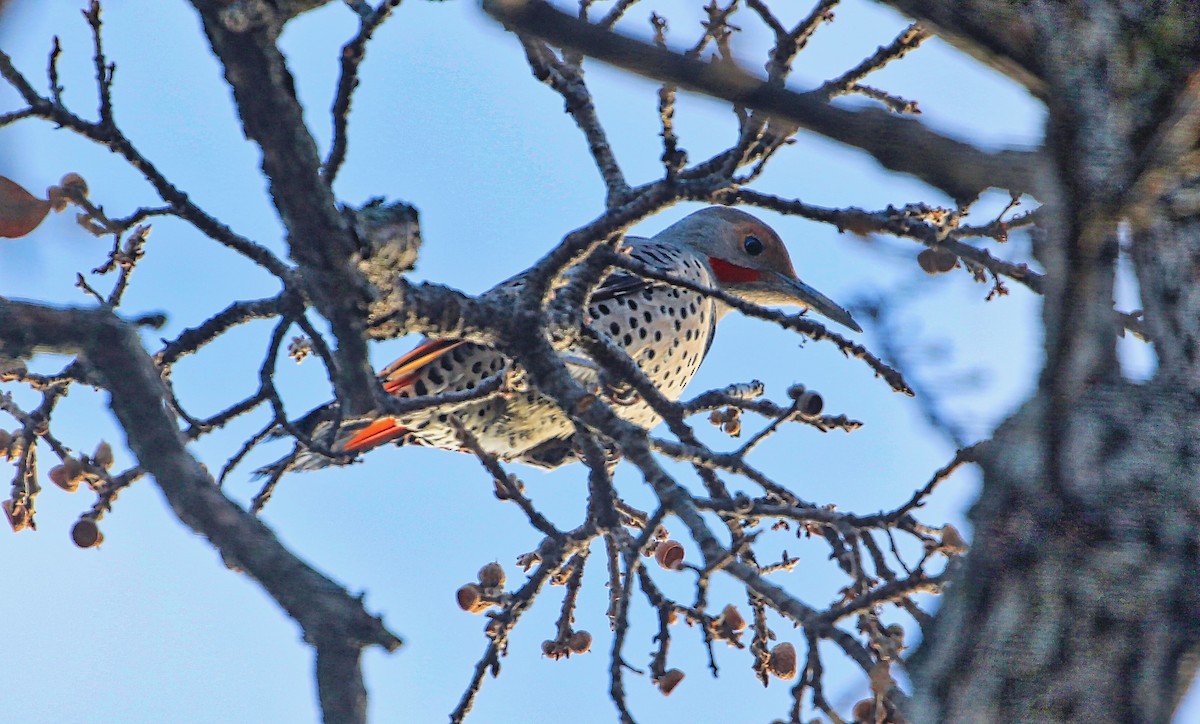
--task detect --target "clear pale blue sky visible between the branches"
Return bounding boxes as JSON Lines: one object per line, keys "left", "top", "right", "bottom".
{"left": 0, "top": 0, "right": 1176, "bottom": 723}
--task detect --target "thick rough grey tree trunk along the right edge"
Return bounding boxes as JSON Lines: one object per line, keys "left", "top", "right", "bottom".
{"left": 911, "top": 1, "right": 1200, "bottom": 722}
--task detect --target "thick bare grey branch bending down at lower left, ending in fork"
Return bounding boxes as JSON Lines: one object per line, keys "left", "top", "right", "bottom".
{"left": 0, "top": 301, "right": 401, "bottom": 722}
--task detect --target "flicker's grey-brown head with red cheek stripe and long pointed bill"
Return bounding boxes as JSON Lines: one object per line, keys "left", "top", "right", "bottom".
{"left": 659, "top": 207, "right": 863, "bottom": 331}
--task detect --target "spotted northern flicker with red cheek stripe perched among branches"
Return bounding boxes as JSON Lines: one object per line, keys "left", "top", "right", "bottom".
{"left": 267, "top": 207, "right": 862, "bottom": 472}
